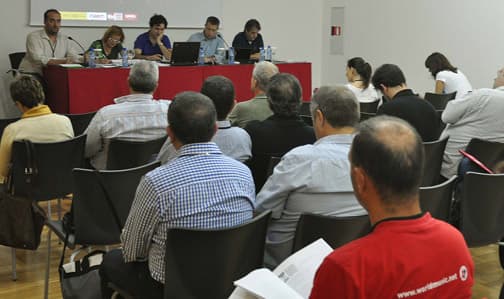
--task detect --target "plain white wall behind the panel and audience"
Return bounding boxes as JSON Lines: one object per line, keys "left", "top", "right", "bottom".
{"left": 0, "top": 0, "right": 504, "bottom": 112}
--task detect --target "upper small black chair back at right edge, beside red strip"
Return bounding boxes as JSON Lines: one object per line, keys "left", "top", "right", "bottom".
{"left": 465, "top": 138, "right": 504, "bottom": 169}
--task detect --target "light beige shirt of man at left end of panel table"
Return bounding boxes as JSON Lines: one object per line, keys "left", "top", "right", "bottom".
{"left": 19, "top": 29, "right": 79, "bottom": 74}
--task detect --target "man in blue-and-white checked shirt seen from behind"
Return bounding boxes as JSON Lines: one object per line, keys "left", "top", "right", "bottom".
{"left": 100, "top": 92, "right": 255, "bottom": 298}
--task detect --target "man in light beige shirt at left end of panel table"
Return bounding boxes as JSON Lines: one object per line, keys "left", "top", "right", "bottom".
{"left": 19, "top": 9, "right": 81, "bottom": 76}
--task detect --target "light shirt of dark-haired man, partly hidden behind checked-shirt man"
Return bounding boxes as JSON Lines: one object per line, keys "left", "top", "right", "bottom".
{"left": 157, "top": 120, "right": 252, "bottom": 164}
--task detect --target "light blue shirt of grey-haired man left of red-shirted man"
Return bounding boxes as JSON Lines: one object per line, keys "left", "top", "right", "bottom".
{"left": 255, "top": 135, "right": 367, "bottom": 267}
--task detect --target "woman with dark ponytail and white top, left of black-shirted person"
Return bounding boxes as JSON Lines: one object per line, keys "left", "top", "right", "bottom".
{"left": 345, "top": 57, "right": 380, "bottom": 103}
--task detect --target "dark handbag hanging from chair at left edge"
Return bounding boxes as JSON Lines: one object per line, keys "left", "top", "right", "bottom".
{"left": 0, "top": 140, "right": 46, "bottom": 250}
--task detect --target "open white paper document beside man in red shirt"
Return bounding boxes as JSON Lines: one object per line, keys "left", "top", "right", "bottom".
{"left": 229, "top": 239, "right": 333, "bottom": 299}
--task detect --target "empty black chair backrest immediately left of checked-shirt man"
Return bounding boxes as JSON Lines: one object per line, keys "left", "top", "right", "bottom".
{"left": 72, "top": 162, "right": 160, "bottom": 245}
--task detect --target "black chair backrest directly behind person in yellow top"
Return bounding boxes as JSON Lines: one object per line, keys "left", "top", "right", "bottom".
{"left": 11, "top": 135, "right": 86, "bottom": 201}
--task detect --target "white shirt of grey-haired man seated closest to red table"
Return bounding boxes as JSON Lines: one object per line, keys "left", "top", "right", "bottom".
{"left": 85, "top": 94, "right": 168, "bottom": 169}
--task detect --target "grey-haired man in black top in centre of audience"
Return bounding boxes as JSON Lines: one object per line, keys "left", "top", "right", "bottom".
{"left": 245, "top": 73, "right": 315, "bottom": 191}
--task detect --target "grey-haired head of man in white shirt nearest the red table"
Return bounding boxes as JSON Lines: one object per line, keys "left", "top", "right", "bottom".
{"left": 128, "top": 60, "right": 159, "bottom": 93}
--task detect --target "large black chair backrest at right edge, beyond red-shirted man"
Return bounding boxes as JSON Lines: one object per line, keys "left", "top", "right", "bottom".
{"left": 460, "top": 172, "right": 504, "bottom": 246}
